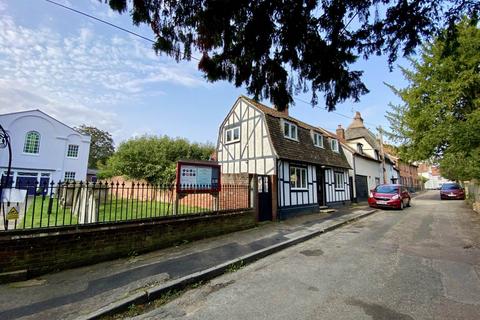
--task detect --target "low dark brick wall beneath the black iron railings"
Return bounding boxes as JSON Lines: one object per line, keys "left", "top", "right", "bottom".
{"left": 0, "top": 210, "right": 255, "bottom": 277}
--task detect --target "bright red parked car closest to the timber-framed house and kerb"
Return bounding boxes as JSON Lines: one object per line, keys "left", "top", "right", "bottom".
{"left": 368, "top": 184, "right": 411, "bottom": 210}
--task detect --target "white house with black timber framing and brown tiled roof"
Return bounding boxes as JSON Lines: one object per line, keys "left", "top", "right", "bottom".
{"left": 217, "top": 96, "right": 351, "bottom": 220}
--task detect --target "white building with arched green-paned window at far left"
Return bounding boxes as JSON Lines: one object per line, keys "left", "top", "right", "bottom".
{"left": 0, "top": 110, "right": 90, "bottom": 194}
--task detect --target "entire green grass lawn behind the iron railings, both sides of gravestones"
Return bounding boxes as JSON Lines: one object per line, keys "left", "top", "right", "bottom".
{"left": 17, "top": 196, "right": 206, "bottom": 229}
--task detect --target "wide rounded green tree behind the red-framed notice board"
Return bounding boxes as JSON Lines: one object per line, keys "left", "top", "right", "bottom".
{"left": 99, "top": 136, "right": 215, "bottom": 184}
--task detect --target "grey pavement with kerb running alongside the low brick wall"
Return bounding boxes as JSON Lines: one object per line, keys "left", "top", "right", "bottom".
{"left": 0, "top": 201, "right": 375, "bottom": 320}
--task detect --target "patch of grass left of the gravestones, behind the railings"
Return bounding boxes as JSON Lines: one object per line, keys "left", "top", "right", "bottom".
{"left": 17, "top": 196, "right": 78, "bottom": 229}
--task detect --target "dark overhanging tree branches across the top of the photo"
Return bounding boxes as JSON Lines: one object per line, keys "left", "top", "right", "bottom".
{"left": 104, "top": 0, "right": 480, "bottom": 110}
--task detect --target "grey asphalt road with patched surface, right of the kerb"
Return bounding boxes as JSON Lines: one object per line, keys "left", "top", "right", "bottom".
{"left": 129, "top": 191, "right": 480, "bottom": 320}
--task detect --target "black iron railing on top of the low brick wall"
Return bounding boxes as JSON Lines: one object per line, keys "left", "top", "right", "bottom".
{"left": 0, "top": 181, "right": 250, "bottom": 231}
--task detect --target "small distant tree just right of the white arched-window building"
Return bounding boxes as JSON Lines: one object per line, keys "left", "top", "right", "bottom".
{"left": 75, "top": 124, "right": 115, "bottom": 169}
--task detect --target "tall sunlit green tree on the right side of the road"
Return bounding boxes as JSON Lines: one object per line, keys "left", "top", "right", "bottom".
{"left": 387, "top": 19, "right": 480, "bottom": 180}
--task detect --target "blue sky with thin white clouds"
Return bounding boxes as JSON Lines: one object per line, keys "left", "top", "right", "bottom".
{"left": 0, "top": 0, "right": 409, "bottom": 145}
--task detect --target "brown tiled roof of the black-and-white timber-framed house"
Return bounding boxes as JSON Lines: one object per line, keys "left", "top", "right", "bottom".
{"left": 242, "top": 97, "right": 350, "bottom": 168}
